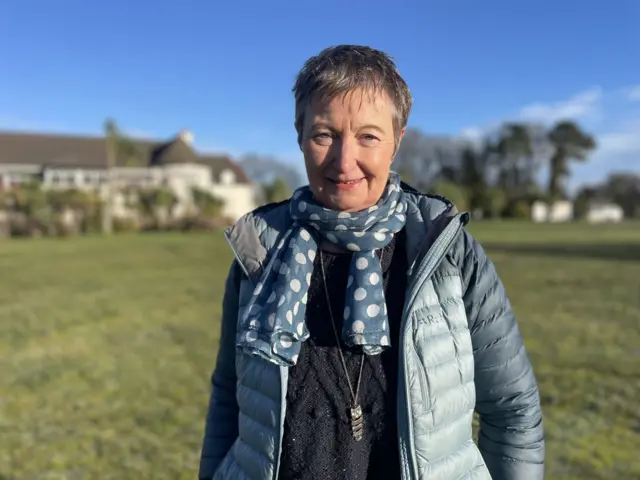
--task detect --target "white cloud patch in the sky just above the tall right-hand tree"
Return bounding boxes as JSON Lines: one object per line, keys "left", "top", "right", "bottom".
{"left": 519, "top": 87, "right": 602, "bottom": 124}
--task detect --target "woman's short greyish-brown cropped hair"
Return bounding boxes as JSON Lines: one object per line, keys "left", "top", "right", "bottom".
{"left": 292, "top": 45, "right": 412, "bottom": 146}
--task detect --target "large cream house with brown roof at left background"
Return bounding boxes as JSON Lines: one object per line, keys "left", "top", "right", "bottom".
{"left": 0, "top": 131, "right": 256, "bottom": 221}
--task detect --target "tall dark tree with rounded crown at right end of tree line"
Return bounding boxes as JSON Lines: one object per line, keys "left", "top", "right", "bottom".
{"left": 548, "top": 120, "right": 596, "bottom": 200}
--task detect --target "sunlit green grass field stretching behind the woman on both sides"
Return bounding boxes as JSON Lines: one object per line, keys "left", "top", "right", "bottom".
{"left": 0, "top": 223, "right": 640, "bottom": 480}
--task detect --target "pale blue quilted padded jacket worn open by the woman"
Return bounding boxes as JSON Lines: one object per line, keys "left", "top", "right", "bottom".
{"left": 199, "top": 185, "right": 544, "bottom": 480}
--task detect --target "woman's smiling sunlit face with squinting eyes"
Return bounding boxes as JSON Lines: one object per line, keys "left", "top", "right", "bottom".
{"left": 301, "top": 90, "right": 404, "bottom": 212}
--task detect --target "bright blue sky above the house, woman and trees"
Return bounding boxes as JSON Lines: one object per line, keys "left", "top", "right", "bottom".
{"left": 0, "top": 0, "right": 640, "bottom": 187}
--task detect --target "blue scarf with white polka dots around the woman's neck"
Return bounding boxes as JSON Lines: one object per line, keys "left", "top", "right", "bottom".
{"left": 236, "top": 174, "right": 407, "bottom": 366}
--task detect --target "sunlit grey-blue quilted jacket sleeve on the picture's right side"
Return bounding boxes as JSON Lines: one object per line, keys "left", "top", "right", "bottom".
{"left": 459, "top": 231, "right": 545, "bottom": 480}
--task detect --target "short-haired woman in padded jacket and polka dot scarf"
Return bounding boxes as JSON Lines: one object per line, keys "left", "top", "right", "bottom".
{"left": 200, "top": 45, "right": 544, "bottom": 480}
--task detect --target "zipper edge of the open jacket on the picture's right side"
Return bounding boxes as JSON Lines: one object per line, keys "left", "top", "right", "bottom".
{"left": 398, "top": 213, "right": 468, "bottom": 480}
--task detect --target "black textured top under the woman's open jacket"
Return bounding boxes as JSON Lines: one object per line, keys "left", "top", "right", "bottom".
{"left": 279, "top": 231, "right": 407, "bottom": 480}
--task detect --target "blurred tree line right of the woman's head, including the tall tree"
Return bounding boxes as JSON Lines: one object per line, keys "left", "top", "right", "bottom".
{"left": 395, "top": 121, "right": 596, "bottom": 218}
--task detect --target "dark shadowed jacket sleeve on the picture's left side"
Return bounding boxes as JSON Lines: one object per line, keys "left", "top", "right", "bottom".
{"left": 198, "top": 262, "right": 241, "bottom": 480}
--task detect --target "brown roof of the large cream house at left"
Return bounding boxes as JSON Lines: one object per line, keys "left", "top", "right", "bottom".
{"left": 0, "top": 132, "right": 250, "bottom": 183}
